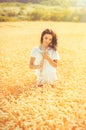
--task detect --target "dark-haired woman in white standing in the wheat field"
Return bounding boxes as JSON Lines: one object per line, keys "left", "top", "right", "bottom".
{"left": 30, "top": 29, "right": 59, "bottom": 86}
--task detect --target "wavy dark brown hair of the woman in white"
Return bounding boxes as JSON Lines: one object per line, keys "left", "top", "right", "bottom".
{"left": 40, "top": 29, "right": 58, "bottom": 50}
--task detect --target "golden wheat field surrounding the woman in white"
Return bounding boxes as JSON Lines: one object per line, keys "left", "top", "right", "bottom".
{"left": 0, "top": 22, "right": 86, "bottom": 130}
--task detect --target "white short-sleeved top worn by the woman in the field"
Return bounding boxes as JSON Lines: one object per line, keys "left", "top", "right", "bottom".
{"left": 31, "top": 47, "right": 60, "bottom": 83}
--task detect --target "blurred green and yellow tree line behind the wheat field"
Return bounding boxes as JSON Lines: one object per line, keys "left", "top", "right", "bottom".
{"left": 0, "top": 0, "right": 86, "bottom": 22}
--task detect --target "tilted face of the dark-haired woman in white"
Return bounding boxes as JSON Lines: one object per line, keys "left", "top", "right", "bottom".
{"left": 42, "top": 34, "right": 52, "bottom": 47}
